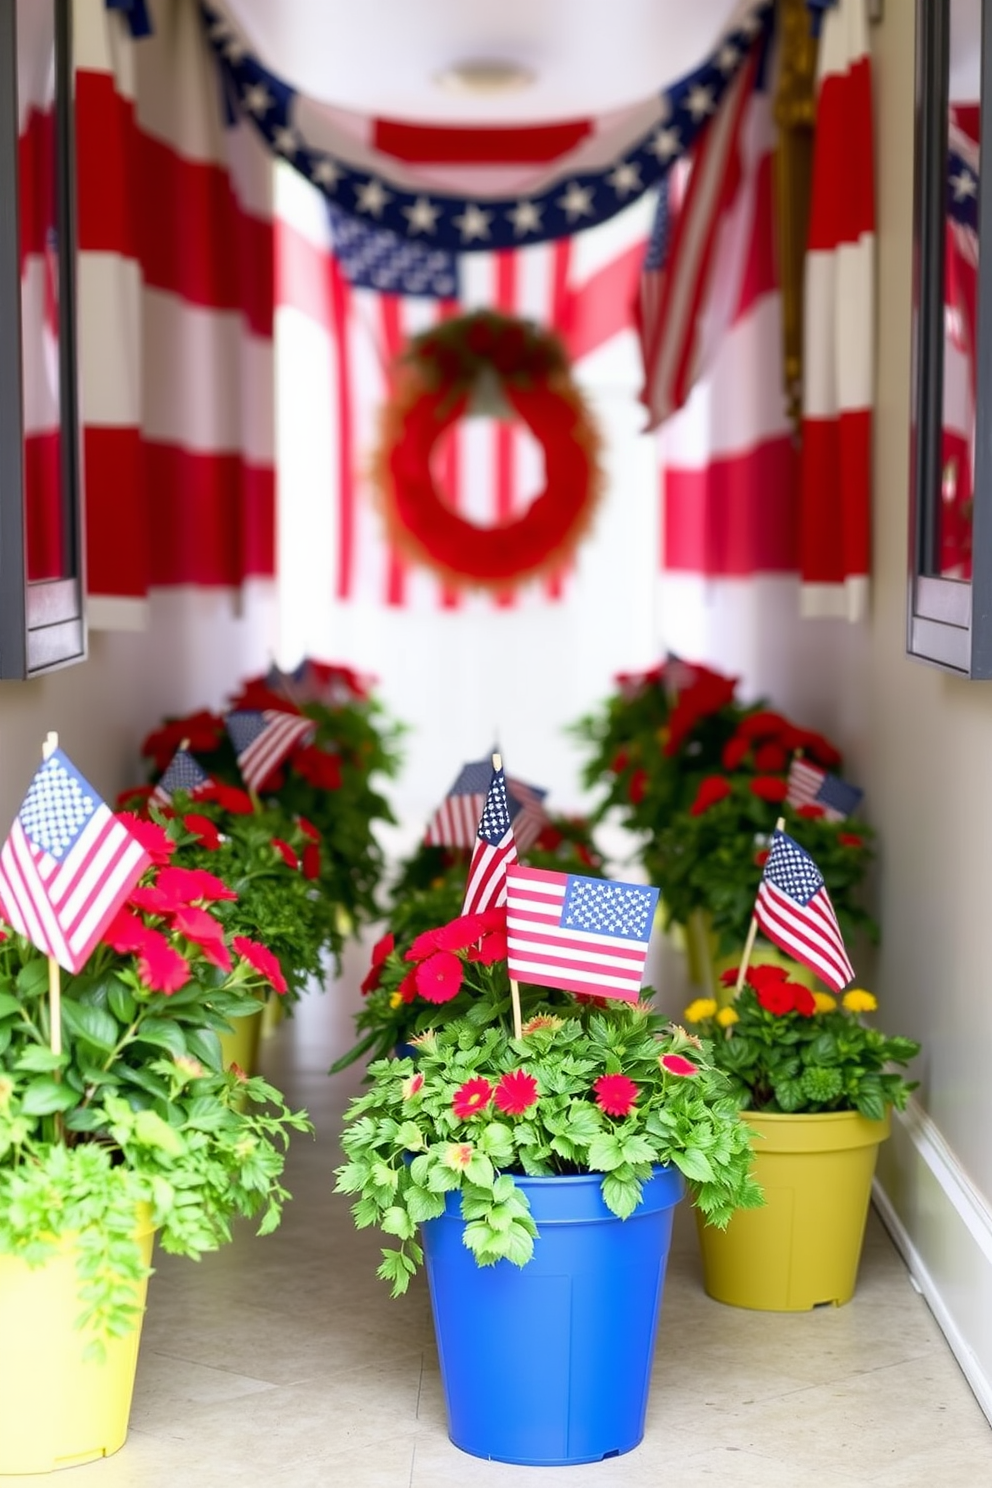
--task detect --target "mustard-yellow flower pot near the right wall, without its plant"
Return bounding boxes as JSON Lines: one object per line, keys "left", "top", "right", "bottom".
{"left": 696, "top": 1112, "right": 889, "bottom": 1312}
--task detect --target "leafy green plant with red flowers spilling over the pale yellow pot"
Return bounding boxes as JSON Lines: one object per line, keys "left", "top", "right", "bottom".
{"left": 0, "top": 820, "right": 311, "bottom": 1351}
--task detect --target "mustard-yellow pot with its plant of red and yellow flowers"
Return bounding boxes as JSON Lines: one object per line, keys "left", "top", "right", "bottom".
{"left": 686, "top": 964, "right": 919, "bottom": 1312}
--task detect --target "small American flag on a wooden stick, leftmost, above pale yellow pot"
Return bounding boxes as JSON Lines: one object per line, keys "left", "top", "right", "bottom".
{"left": 0, "top": 750, "right": 152, "bottom": 972}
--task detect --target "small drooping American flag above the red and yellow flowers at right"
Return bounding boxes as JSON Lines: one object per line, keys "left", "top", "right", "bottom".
{"left": 754, "top": 830, "right": 854, "bottom": 992}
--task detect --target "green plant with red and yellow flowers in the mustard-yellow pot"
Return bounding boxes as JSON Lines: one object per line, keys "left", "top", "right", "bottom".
{"left": 684, "top": 966, "right": 919, "bottom": 1120}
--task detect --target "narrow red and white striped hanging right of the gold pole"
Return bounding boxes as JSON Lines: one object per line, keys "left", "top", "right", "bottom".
{"left": 800, "top": 0, "right": 875, "bottom": 620}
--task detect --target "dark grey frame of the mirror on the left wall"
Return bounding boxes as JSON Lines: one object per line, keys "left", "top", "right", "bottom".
{"left": 0, "top": 0, "right": 86, "bottom": 679}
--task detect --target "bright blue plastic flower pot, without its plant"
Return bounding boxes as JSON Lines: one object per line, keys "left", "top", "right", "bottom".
{"left": 422, "top": 1167, "right": 684, "bottom": 1467}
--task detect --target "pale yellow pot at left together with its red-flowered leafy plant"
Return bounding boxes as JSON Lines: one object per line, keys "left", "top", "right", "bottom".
{"left": 0, "top": 809, "right": 309, "bottom": 1475}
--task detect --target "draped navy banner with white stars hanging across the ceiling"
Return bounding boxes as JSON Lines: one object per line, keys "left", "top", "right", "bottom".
{"left": 201, "top": 0, "right": 773, "bottom": 253}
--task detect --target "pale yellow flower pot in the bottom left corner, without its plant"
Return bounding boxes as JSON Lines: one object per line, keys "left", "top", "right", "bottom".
{"left": 0, "top": 1222, "right": 153, "bottom": 1476}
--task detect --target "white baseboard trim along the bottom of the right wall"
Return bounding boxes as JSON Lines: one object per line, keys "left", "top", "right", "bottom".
{"left": 875, "top": 1097, "right": 992, "bottom": 1421}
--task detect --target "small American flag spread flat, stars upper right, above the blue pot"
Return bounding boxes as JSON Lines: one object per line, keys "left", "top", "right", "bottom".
{"left": 506, "top": 868, "right": 657, "bottom": 1003}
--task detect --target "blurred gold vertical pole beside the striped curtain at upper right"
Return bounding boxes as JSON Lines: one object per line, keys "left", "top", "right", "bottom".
{"left": 775, "top": 0, "right": 817, "bottom": 430}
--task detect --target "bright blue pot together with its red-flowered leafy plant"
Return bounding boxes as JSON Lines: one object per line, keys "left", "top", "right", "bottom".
{"left": 338, "top": 911, "right": 760, "bottom": 1464}
